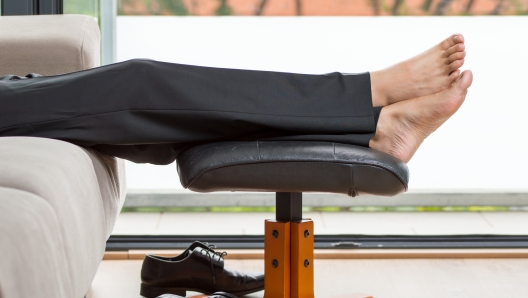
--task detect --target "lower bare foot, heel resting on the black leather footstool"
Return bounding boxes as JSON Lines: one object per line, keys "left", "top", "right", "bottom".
{"left": 369, "top": 70, "right": 473, "bottom": 163}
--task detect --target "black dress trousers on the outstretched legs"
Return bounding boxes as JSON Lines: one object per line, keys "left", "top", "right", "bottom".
{"left": 0, "top": 60, "right": 380, "bottom": 164}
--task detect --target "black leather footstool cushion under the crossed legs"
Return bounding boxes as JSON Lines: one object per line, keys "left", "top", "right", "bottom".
{"left": 177, "top": 141, "right": 409, "bottom": 196}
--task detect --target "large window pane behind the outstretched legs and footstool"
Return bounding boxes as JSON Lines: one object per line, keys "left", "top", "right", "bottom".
{"left": 107, "top": 0, "right": 528, "bottom": 235}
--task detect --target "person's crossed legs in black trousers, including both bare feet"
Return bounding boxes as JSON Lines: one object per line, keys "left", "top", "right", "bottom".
{"left": 0, "top": 35, "right": 472, "bottom": 164}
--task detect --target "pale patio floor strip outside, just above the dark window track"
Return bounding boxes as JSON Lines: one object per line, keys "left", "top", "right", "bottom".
{"left": 113, "top": 212, "right": 528, "bottom": 235}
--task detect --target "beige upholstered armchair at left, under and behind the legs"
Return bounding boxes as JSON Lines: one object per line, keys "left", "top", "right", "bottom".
{"left": 0, "top": 15, "right": 126, "bottom": 298}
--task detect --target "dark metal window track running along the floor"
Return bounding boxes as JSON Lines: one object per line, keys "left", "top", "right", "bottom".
{"left": 106, "top": 235, "right": 528, "bottom": 251}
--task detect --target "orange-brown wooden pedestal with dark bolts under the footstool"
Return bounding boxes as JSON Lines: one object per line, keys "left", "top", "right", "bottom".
{"left": 264, "top": 219, "right": 314, "bottom": 298}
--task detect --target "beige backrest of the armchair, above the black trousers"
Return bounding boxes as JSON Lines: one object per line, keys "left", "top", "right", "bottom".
{"left": 0, "top": 15, "right": 101, "bottom": 76}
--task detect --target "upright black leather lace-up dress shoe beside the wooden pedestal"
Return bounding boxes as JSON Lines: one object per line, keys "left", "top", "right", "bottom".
{"left": 140, "top": 241, "right": 264, "bottom": 298}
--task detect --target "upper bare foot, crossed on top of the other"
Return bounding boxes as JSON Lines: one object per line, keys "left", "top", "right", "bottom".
{"left": 370, "top": 34, "right": 466, "bottom": 107}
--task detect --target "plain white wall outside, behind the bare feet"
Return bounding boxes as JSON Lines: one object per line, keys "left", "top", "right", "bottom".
{"left": 117, "top": 17, "right": 528, "bottom": 191}
